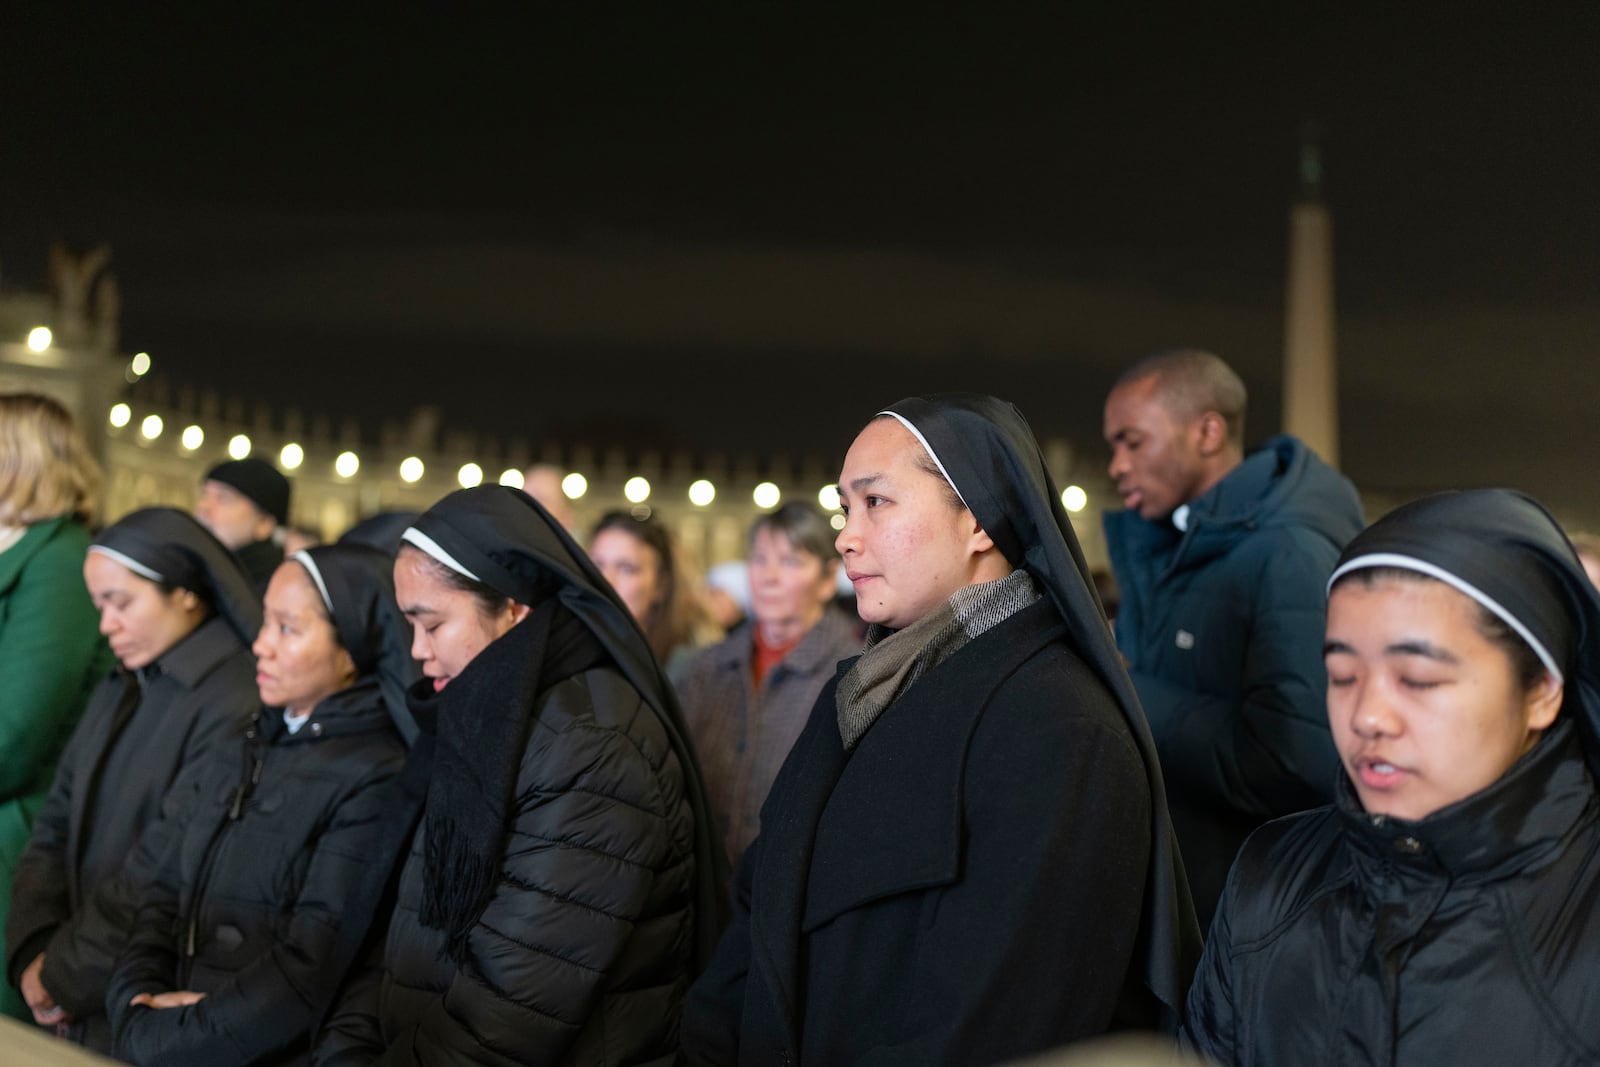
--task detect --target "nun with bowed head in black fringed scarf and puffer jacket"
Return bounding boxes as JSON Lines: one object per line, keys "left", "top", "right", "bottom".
{"left": 315, "top": 486, "right": 723, "bottom": 1065}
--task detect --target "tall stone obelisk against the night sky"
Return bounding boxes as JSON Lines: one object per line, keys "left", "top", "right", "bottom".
{"left": 1283, "top": 130, "right": 1339, "bottom": 467}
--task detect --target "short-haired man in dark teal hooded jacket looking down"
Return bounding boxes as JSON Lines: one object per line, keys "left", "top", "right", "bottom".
{"left": 1102, "top": 349, "right": 1362, "bottom": 928}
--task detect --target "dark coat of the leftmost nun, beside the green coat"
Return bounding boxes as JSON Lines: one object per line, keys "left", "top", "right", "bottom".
{"left": 6, "top": 616, "right": 259, "bottom": 1049}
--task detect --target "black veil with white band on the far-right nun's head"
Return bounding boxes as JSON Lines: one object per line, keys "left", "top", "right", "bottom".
{"left": 1334, "top": 490, "right": 1600, "bottom": 777}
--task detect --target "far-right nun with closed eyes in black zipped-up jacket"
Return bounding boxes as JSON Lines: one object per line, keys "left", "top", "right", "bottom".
{"left": 1184, "top": 490, "right": 1600, "bottom": 1067}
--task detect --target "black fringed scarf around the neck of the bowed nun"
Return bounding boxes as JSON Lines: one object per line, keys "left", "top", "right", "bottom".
{"left": 408, "top": 600, "right": 610, "bottom": 963}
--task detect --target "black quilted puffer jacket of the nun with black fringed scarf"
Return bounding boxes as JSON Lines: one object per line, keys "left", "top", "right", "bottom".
{"left": 317, "top": 667, "right": 694, "bottom": 1065}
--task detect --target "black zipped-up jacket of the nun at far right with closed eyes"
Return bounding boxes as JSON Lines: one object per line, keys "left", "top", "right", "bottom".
{"left": 1184, "top": 720, "right": 1600, "bottom": 1067}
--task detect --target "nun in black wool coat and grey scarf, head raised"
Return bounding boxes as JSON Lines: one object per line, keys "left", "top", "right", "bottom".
{"left": 685, "top": 395, "right": 1198, "bottom": 1067}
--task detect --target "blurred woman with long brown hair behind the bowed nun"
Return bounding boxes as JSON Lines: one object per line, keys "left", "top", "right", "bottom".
{"left": 589, "top": 512, "right": 709, "bottom": 681}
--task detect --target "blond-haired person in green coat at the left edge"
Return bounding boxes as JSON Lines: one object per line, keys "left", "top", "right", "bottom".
{"left": 0, "top": 394, "right": 112, "bottom": 1019}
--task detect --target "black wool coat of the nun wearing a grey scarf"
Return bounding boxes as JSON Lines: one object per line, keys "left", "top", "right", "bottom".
{"left": 683, "top": 598, "right": 1160, "bottom": 1067}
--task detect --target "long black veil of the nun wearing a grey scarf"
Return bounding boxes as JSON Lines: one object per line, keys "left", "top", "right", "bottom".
{"left": 886, "top": 394, "right": 1200, "bottom": 1030}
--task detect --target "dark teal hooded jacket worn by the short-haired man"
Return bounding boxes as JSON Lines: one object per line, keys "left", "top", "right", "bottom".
{"left": 1106, "top": 437, "right": 1362, "bottom": 925}
